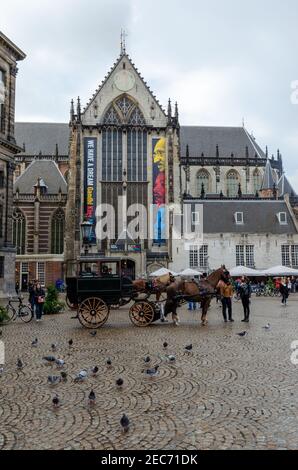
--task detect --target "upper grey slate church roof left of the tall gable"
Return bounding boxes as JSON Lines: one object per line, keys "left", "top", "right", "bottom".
{"left": 15, "top": 122, "right": 69, "bottom": 156}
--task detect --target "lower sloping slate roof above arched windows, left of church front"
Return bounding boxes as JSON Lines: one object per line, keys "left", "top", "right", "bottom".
{"left": 14, "top": 160, "right": 67, "bottom": 194}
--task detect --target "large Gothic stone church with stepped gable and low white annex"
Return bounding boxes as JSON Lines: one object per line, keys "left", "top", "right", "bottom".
{"left": 15, "top": 45, "right": 298, "bottom": 282}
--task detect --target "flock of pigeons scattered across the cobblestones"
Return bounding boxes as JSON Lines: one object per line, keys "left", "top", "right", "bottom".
{"left": 0, "top": 323, "right": 271, "bottom": 432}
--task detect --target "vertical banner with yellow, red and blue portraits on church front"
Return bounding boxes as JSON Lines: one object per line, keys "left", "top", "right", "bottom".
{"left": 152, "top": 137, "right": 166, "bottom": 244}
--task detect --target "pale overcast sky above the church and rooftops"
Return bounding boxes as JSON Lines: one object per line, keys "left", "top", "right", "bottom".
{"left": 0, "top": 0, "right": 298, "bottom": 192}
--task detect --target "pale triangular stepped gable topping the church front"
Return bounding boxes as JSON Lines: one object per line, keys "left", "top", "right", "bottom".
{"left": 82, "top": 54, "right": 167, "bottom": 127}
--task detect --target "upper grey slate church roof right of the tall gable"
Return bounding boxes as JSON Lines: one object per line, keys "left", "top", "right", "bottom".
{"left": 180, "top": 126, "right": 266, "bottom": 158}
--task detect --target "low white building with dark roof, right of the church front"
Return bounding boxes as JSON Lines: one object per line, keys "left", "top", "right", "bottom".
{"left": 170, "top": 199, "right": 298, "bottom": 272}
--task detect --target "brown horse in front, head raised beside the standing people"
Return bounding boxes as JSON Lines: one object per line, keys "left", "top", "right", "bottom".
{"left": 165, "top": 266, "right": 226, "bottom": 326}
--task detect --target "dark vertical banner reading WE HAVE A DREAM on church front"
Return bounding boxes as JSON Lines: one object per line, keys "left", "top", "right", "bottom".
{"left": 84, "top": 137, "right": 97, "bottom": 244}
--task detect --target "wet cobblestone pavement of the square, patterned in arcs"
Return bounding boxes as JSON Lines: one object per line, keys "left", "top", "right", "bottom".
{"left": 0, "top": 296, "right": 298, "bottom": 450}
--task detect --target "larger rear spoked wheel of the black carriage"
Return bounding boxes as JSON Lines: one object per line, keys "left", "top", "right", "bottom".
{"left": 78, "top": 297, "right": 109, "bottom": 329}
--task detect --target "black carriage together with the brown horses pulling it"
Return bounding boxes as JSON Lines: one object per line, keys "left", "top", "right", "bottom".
{"left": 66, "top": 257, "right": 226, "bottom": 329}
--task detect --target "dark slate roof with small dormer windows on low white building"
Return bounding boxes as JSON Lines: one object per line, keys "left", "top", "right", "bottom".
{"left": 184, "top": 199, "right": 297, "bottom": 235}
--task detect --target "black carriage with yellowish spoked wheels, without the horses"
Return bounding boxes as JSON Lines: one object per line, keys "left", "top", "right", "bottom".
{"left": 66, "top": 257, "right": 160, "bottom": 329}
